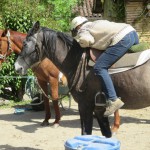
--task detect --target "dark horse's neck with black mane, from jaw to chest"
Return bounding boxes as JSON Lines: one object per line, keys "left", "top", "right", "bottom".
{"left": 43, "top": 29, "right": 83, "bottom": 86}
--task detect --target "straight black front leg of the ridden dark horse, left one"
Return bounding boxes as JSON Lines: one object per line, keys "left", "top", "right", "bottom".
{"left": 78, "top": 103, "right": 93, "bottom": 135}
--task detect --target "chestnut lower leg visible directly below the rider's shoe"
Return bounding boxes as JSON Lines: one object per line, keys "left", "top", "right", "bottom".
{"left": 111, "top": 110, "right": 120, "bottom": 134}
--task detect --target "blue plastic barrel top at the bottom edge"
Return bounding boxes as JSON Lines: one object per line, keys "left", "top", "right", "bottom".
{"left": 65, "top": 135, "right": 120, "bottom": 150}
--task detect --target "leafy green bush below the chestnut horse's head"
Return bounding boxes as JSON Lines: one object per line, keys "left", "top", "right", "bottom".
{"left": 0, "top": 53, "right": 26, "bottom": 101}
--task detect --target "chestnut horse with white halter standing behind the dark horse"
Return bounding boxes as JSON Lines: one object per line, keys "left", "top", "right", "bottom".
{"left": 0, "top": 30, "right": 67, "bottom": 126}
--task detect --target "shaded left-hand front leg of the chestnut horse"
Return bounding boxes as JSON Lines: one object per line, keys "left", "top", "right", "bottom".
{"left": 38, "top": 79, "right": 51, "bottom": 126}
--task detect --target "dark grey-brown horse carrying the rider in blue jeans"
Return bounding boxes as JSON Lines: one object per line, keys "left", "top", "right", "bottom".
{"left": 15, "top": 22, "right": 150, "bottom": 136}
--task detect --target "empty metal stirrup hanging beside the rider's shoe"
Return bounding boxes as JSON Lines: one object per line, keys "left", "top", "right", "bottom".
{"left": 95, "top": 92, "right": 106, "bottom": 106}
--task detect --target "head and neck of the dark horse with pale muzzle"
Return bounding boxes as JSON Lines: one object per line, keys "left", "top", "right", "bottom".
{"left": 15, "top": 22, "right": 84, "bottom": 76}
